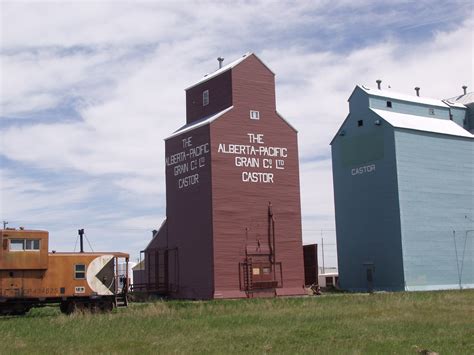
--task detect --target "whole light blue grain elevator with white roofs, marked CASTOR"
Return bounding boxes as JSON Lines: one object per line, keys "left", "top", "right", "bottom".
{"left": 331, "top": 83, "right": 474, "bottom": 291}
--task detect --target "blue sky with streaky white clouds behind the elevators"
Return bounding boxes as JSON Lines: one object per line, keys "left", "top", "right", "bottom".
{"left": 0, "top": 0, "right": 473, "bottom": 265}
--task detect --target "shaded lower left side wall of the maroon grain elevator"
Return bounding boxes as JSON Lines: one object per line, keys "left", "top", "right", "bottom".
{"left": 166, "top": 126, "right": 213, "bottom": 298}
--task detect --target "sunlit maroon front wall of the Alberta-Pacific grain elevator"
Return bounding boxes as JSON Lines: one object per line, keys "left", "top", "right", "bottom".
{"left": 211, "top": 56, "right": 304, "bottom": 297}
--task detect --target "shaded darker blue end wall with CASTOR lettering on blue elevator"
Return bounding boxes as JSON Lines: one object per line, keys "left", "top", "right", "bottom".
{"left": 332, "top": 107, "right": 404, "bottom": 291}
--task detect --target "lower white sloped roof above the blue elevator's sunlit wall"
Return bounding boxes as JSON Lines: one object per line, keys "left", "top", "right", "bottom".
{"left": 371, "top": 109, "right": 474, "bottom": 138}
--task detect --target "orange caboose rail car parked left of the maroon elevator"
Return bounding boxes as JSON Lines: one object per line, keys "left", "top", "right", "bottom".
{"left": 0, "top": 228, "right": 129, "bottom": 315}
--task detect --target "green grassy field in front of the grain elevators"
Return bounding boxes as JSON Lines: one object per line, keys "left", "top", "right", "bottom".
{"left": 0, "top": 290, "right": 474, "bottom": 354}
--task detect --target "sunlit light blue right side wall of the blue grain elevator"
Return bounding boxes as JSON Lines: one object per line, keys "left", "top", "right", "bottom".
{"left": 395, "top": 130, "right": 474, "bottom": 290}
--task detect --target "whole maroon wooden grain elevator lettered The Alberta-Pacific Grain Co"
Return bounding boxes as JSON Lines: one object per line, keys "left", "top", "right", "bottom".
{"left": 145, "top": 54, "right": 304, "bottom": 299}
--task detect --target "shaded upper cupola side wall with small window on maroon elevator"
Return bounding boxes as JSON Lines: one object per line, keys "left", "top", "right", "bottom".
{"left": 186, "top": 70, "right": 232, "bottom": 124}
